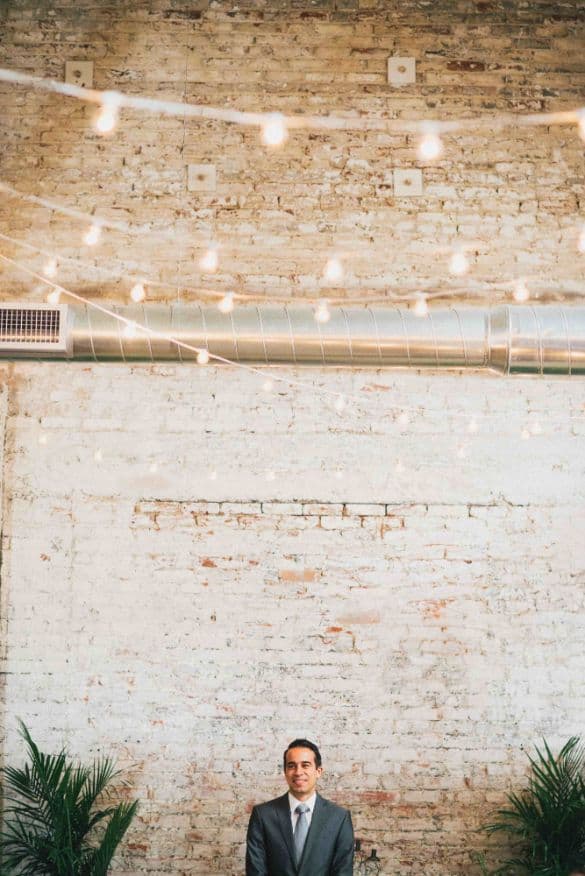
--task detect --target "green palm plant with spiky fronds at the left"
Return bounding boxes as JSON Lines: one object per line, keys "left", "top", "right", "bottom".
{"left": 0, "top": 722, "right": 138, "bottom": 876}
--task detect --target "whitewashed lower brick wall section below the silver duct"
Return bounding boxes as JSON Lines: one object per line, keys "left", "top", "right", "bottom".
{"left": 2, "top": 363, "right": 585, "bottom": 876}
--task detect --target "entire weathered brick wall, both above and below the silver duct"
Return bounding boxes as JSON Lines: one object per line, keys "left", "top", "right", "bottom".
{"left": 0, "top": 0, "right": 585, "bottom": 876}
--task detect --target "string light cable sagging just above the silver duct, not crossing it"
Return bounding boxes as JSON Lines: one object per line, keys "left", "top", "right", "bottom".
{"left": 0, "top": 226, "right": 585, "bottom": 308}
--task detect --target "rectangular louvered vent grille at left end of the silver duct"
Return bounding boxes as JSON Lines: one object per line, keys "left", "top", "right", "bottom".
{"left": 0, "top": 304, "right": 68, "bottom": 356}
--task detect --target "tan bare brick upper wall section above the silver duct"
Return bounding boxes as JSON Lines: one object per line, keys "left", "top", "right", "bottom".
{"left": 0, "top": 0, "right": 585, "bottom": 300}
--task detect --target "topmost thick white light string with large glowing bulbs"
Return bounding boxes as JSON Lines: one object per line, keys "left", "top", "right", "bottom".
{"left": 0, "top": 68, "right": 585, "bottom": 136}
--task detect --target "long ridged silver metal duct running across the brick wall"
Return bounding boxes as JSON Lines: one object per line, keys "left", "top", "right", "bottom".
{"left": 0, "top": 304, "right": 585, "bottom": 375}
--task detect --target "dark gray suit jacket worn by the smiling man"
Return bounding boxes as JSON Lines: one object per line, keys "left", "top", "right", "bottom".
{"left": 246, "top": 794, "right": 353, "bottom": 876}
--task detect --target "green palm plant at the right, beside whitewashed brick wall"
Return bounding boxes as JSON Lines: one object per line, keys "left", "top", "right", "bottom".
{"left": 476, "top": 736, "right": 585, "bottom": 876}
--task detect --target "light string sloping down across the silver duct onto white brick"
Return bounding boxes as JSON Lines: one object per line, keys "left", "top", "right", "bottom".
{"left": 0, "top": 252, "right": 585, "bottom": 426}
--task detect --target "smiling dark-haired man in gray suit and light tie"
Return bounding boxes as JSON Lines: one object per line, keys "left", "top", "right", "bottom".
{"left": 246, "top": 739, "right": 353, "bottom": 876}
